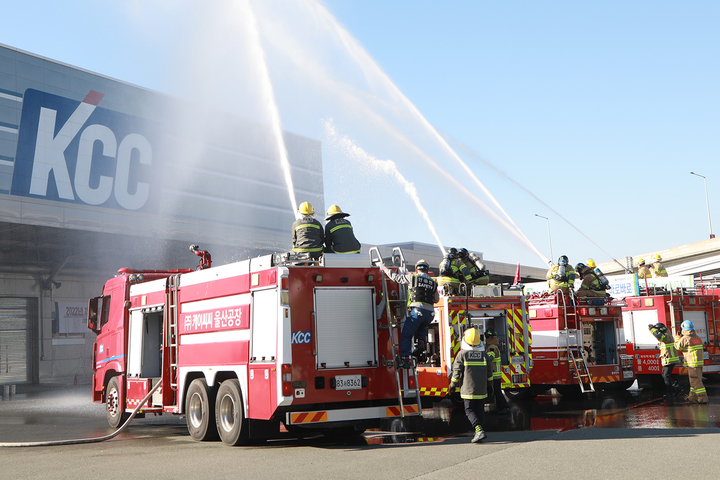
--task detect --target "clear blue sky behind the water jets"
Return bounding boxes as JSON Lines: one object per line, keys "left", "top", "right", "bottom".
{"left": 0, "top": 0, "right": 720, "bottom": 266}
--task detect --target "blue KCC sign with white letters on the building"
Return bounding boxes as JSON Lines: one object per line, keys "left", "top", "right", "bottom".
{"left": 11, "top": 89, "right": 160, "bottom": 210}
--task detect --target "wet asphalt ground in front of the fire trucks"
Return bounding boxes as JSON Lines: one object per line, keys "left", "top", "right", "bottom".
{"left": 0, "top": 382, "right": 720, "bottom": 479}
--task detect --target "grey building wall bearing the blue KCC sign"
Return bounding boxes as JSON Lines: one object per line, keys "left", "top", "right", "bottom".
{"left": 0, "top": 45, "right": 325, "bottom": 384}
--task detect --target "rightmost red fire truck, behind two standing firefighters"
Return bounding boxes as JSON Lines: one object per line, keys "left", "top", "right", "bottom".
{"left": 623, "top": 287, "right": 720, "bottom": 388}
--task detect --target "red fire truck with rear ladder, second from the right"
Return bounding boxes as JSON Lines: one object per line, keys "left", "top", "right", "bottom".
{"left": 528, "top": 291, "right": 635, "bottom": 396}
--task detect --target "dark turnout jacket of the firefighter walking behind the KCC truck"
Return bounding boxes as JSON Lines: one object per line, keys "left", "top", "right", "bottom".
{"left": 450, "top": 346, "right": 493, "bottom": 400}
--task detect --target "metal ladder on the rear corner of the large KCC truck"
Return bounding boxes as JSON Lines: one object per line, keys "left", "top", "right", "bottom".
{"left": 369, "top": 247, "right": 422, "bottom": 417}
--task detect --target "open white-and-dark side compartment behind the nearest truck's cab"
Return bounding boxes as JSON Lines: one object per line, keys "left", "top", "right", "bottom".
{"left": 127, "top": 309, "right": 163, "bottom": 378}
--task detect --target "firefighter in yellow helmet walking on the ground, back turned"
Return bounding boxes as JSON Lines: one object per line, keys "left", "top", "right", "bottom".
{"left": 449, "top": 328, "right": 493, "bottom": 443}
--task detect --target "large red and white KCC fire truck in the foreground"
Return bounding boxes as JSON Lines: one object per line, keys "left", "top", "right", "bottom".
{"left": 88, "top": 251, "right": 422, "bottom": 445}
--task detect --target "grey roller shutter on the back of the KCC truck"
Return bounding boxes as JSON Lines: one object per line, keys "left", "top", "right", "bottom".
{"left": 315, "top": 287, "right": 378, "bottom": 370}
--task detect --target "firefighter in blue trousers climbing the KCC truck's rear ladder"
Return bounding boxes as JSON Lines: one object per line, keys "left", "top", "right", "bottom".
{"left": 381, "top": 260, "right": 440, "bottom": 368}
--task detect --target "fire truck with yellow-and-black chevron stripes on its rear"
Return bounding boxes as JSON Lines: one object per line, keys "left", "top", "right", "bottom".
{"left": 417, "top": 285, "right": 532, "bottom": 399}
